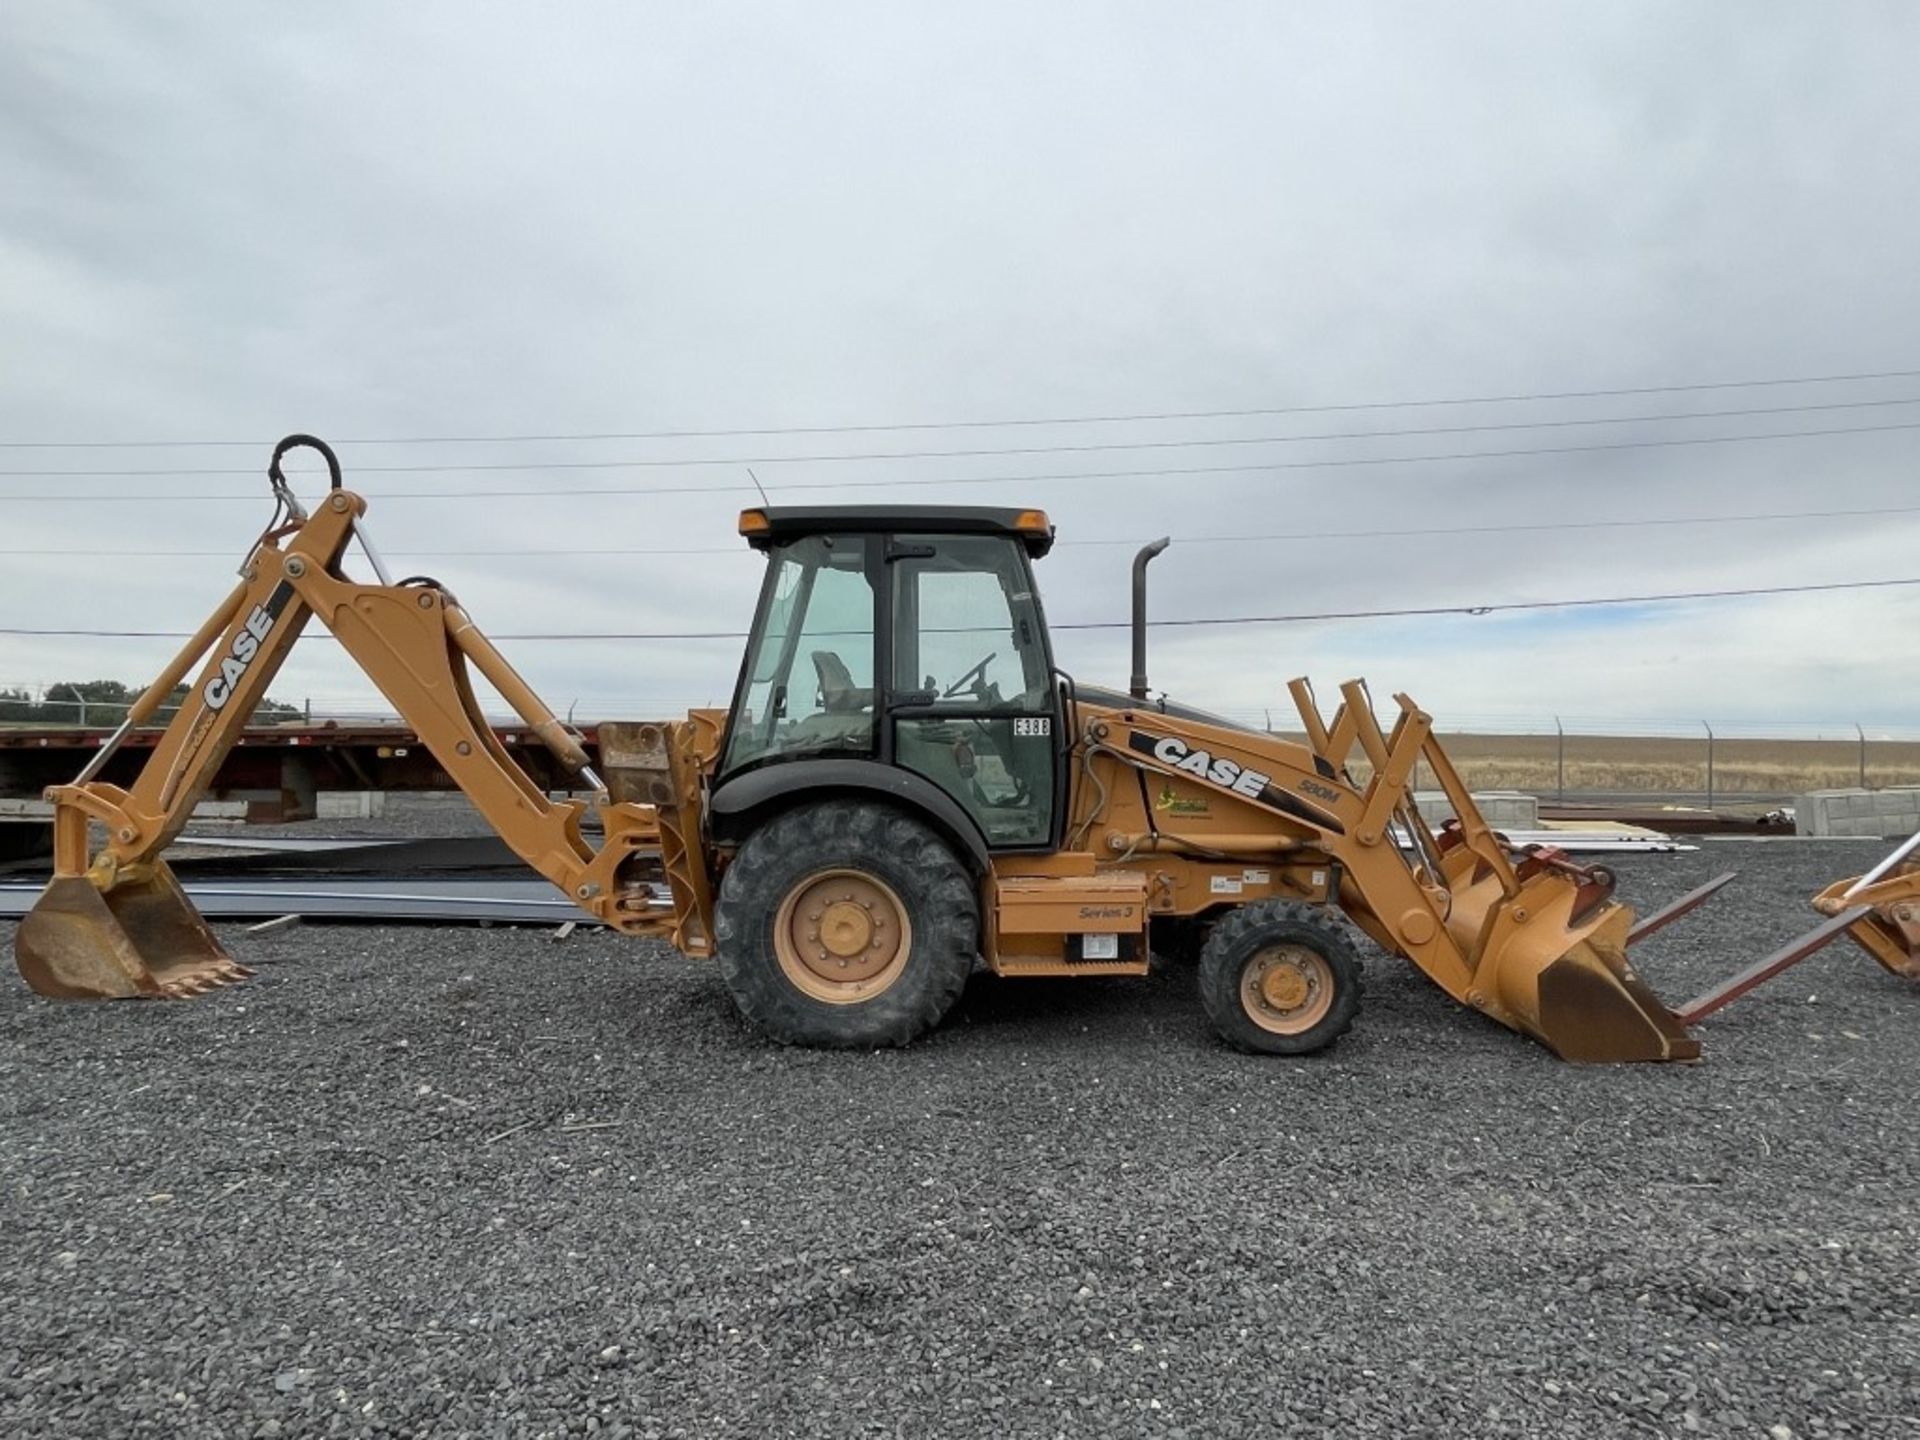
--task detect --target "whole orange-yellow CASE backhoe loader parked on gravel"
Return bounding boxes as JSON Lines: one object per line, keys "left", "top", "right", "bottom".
{"left": 15, "top": 436, "right": 1758, "bottom": 1062}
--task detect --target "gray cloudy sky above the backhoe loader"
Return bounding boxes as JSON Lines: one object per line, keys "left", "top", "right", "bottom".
{"left": 0, "top": 0, "right": 1920, "bottom": 733}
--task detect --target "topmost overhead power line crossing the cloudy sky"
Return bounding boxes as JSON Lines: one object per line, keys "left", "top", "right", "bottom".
{"left": 0, "top": 371, "right": 1920, "bottom": 449}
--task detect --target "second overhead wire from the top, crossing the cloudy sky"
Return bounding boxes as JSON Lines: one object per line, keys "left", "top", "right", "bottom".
{"left": 0, "top": 396, "right": 1920, "bottom": 486}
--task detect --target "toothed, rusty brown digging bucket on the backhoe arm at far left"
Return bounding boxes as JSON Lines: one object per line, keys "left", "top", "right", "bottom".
{"left": 13, "top": 860, "right": 252, "bottom": 1000}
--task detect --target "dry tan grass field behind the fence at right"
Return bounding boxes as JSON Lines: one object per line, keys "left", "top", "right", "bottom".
{"left": 1282, "top": 733, "right": 1920, "bottom": 801}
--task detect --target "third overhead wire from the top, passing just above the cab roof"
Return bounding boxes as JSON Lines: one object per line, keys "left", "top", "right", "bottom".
{"left": 0, "top": 420, "right": 1920, "bottom": 505}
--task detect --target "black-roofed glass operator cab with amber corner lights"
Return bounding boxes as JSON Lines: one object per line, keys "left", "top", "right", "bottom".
{"left": 716, "top": 505, "right": 1062, "bottom": 851}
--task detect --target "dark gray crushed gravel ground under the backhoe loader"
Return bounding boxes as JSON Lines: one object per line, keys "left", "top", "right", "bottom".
{"left": 0, "top": 841, "right": 1920, "bottom": 1436}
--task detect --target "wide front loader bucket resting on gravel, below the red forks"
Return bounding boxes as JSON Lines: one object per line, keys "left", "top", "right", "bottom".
{"left": 1448, "top": 876, "right": 1730, "bottom": 1064}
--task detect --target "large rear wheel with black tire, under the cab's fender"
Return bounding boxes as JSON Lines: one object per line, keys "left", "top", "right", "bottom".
{"left": 714, "top": 801, "right": 979, "bottom": 1048}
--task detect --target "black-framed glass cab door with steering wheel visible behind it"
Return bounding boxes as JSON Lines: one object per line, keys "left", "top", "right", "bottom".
{"left": 887, "top": 536, "right": 1060, "bottom": 851}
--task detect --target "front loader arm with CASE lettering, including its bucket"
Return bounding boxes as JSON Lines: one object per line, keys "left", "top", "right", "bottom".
{"left": 1092, "top": 682, "right": 1699, "bottom": 1060}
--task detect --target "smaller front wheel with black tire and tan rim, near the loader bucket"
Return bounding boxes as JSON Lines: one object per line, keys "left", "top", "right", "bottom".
{"left": 1200, "top": 900, "right": 1363, "bottom": 1054}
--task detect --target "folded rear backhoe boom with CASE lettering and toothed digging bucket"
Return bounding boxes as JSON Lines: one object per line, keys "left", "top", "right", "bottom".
{"left": 15, "top": 436, "right": 708, "bottom": 996}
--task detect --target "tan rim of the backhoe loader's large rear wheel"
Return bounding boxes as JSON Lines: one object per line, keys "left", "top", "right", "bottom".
{"left": 774, "top": 870, "right": 914, "bottom": 1004}
